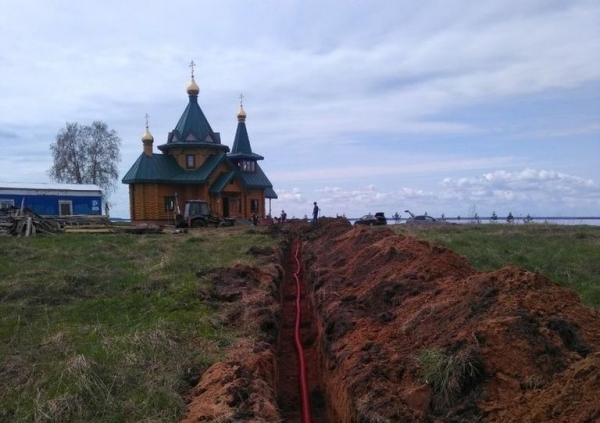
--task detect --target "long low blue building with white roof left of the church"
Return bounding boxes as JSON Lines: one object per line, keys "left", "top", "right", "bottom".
{"left": 0, "top": 182, "right": 103, "bottom": 216}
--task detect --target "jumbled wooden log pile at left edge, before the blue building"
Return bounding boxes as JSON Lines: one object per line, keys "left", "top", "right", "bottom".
{"left": 0, "top": 207, "right": 62, "bottom": 236}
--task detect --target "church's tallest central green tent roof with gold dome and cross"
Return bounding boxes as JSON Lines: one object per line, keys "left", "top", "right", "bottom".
{"left": 158, "top": 68, "right": 229, "bottom": 152}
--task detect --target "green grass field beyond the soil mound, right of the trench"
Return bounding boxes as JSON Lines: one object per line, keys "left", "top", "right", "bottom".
{"left": 394, "top": 224, "right": 600, "bottom": 309}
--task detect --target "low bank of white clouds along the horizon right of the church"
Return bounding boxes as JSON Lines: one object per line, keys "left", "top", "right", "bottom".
{"left": 270, "top": 168, "right": 600, "bottom": 217}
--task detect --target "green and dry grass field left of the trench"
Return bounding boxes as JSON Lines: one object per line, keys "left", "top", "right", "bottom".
{"left": 0, "top": 228, "right": 277, "bottom": 422}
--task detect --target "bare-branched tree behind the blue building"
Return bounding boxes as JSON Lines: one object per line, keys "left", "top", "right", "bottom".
{"left": 48, "top": 121, "right": 121, "bottom": 196}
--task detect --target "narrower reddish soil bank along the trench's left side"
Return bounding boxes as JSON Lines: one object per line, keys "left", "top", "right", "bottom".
{"left": 182, "top": 258, "right": 282, "bottom": 423}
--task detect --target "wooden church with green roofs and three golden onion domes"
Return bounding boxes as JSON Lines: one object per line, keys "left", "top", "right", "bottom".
{"left": 122, "top": 62, "right": 277, "bottom": 225}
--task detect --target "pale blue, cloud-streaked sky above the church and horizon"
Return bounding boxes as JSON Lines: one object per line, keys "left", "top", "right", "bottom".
{"left": 0, "top": 0, "right": 600, "bottom": 222}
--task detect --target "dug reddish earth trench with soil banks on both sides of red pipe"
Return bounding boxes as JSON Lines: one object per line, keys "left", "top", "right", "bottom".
{"left": 183, "top": 219, "right": 600, "bottom": 423}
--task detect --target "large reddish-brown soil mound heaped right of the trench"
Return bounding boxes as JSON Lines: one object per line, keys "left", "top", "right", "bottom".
{"left": 303, "top": 221, "right": 600, "bottom": 422}
